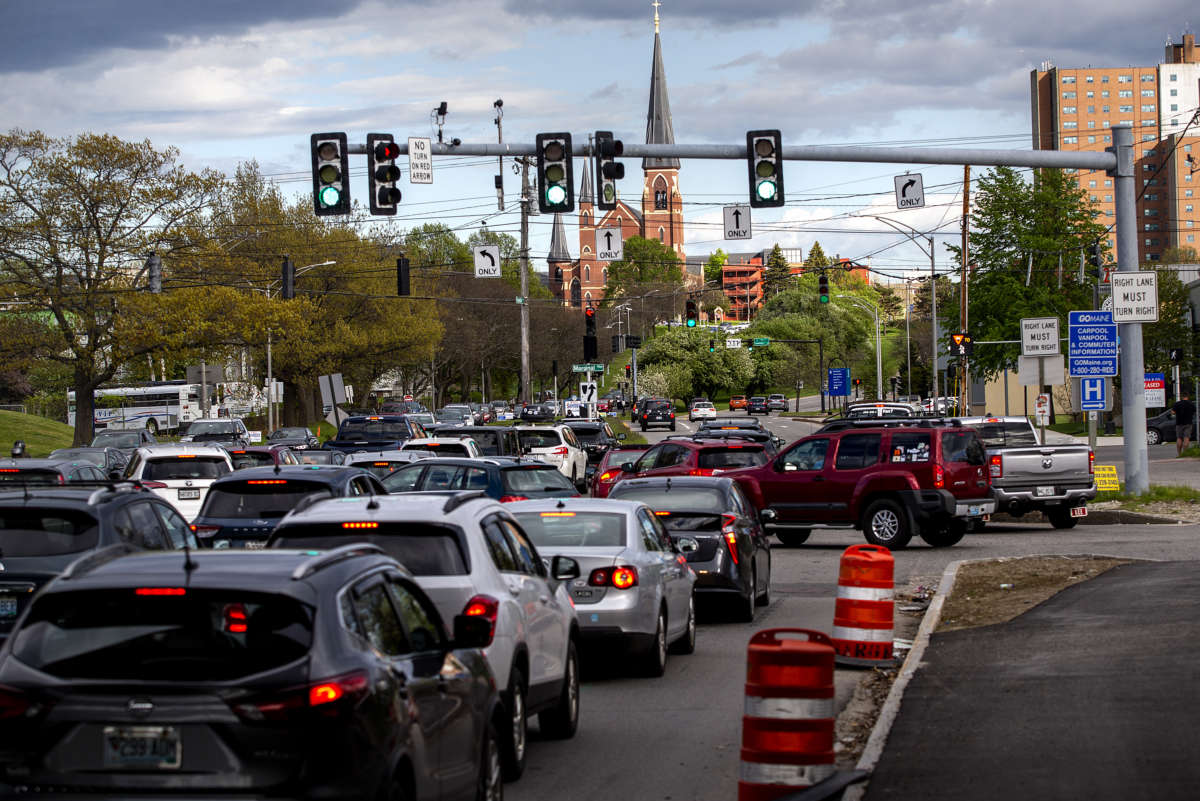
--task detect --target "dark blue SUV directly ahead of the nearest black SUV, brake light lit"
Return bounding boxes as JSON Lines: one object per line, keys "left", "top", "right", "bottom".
{"left": 192, "top": 464, "right": 388, "bottom": 548}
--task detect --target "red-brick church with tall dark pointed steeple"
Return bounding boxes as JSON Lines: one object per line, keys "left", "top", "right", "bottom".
{"left": 546, "top": 4, "right": 685, "bottom": 307}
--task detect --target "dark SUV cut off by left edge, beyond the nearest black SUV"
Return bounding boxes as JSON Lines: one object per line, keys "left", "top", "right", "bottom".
{"left": 0, "top": 483, "right": 197, "bottom": 637}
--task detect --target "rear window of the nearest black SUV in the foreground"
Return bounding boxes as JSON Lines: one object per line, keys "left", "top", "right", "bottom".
{"left": 12, "top": 592, "right": 312, "bottom": 681}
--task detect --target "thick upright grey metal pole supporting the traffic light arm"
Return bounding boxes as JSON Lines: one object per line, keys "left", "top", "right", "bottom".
{"left": 1109, "top": 125, "right": 1150, "bottom": 495}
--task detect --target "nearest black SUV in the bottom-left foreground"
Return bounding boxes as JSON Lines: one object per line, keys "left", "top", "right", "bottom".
{"left": 0, "top": 543, "right": 503, "bottom": 801}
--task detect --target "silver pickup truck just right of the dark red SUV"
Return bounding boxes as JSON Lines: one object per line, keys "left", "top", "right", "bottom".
{"left": 960, "top": 417, "right": 1096, "bottom": 529}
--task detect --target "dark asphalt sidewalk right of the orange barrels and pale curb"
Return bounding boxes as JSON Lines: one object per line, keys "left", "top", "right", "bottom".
{"left": 860, "top": 562, "right": 1200, "bottom": 801}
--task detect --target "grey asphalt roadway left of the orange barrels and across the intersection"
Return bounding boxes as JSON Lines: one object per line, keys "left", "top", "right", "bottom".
{"left": 505, "top": 524, "right": 1200, "bottom": 801}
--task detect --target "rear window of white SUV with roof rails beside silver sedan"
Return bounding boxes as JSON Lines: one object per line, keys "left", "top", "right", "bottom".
{"left": 268, "top": 520, "right": 470, "bottom": 576}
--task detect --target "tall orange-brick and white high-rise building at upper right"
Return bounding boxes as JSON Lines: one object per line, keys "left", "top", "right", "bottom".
{"left": 1030, "top": 34, "right": 1200, "bottom": 263}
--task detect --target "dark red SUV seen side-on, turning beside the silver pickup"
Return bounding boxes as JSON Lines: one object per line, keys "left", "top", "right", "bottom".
{"left": 728, "top": 423, "right": 996, "bottom": 549}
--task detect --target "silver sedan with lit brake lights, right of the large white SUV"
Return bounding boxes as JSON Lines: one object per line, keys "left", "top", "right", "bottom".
{"left": 508, "top": 498, "right": 698, "bottom": 676}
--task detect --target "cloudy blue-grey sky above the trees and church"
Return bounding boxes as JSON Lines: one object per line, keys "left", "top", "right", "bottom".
{"left": 0, "top": 0, "right": 1200, "bottom": 279}
